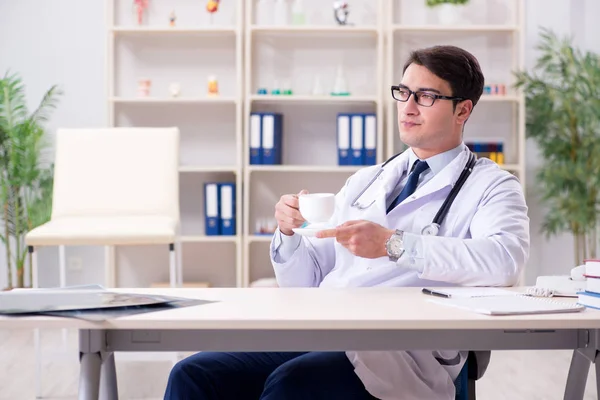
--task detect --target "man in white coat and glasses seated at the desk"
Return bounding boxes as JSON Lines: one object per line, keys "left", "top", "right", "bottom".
{"left": 165, "top": 46, "right": 529, "bottom": 400}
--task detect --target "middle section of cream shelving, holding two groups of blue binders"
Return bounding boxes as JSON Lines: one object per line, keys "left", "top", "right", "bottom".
{"left": 243, "top": 0, "right": 385, "bottom": 286}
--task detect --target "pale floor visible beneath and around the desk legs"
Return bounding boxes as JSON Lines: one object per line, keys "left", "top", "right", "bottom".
{"left": 0, "top": 330, "right": 597, "bottom": 400}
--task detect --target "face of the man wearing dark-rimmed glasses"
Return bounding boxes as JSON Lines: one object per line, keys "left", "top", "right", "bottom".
{"left": 397, "top": 64, "right": 470, "bottom": 155}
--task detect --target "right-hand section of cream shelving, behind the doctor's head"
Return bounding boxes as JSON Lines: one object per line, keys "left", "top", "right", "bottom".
{"left": 386, "top": 0, "right": 526, "bottom": 186}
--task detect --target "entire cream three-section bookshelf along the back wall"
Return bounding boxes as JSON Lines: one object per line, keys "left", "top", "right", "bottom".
{"left": 106, "top": 0, "right": 525, "bottom": 287}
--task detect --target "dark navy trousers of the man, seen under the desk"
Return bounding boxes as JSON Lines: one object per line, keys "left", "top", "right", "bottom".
{"left": 165, "top": 352, "right": 375, "bottom": 400}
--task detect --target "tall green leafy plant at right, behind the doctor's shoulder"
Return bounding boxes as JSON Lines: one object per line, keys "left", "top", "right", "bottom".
{"left": 515, "top": 28, "right": 600, "bottom": 265}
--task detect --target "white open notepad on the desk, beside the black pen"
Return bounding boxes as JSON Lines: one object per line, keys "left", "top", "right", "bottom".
{"left": 429, "top": 295, "right": 585, "bottom": 315}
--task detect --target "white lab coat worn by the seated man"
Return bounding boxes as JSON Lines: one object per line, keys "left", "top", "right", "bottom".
{"left": 271, "top": 146, "right": 529, "bottom": 400}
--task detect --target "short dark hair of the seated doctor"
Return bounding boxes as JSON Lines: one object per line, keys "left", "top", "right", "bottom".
{"left": 402, "top": 46, "right": 484, "bottom": 107}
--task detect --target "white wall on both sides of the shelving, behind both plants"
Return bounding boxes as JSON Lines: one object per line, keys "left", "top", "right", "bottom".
{"left": 0, "top": 0, "right": 600, "bottom": 287}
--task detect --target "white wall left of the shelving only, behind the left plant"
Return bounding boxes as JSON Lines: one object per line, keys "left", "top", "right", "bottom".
{"left": 0, "top": 0, "right": 106, "bottom": 287}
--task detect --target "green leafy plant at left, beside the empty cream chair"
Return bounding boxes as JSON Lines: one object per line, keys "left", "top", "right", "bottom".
{"left": 0, "top": 73, "right": 61, "bottom": 287}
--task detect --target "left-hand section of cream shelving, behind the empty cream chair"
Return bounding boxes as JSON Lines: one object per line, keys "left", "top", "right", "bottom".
{"left": 106, "top": 0, "right": 244, "bottom": 286}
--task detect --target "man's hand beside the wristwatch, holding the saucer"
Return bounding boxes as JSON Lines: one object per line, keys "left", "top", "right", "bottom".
{"left": 317, "top": 221, "right": 394, "bottom": 258}
